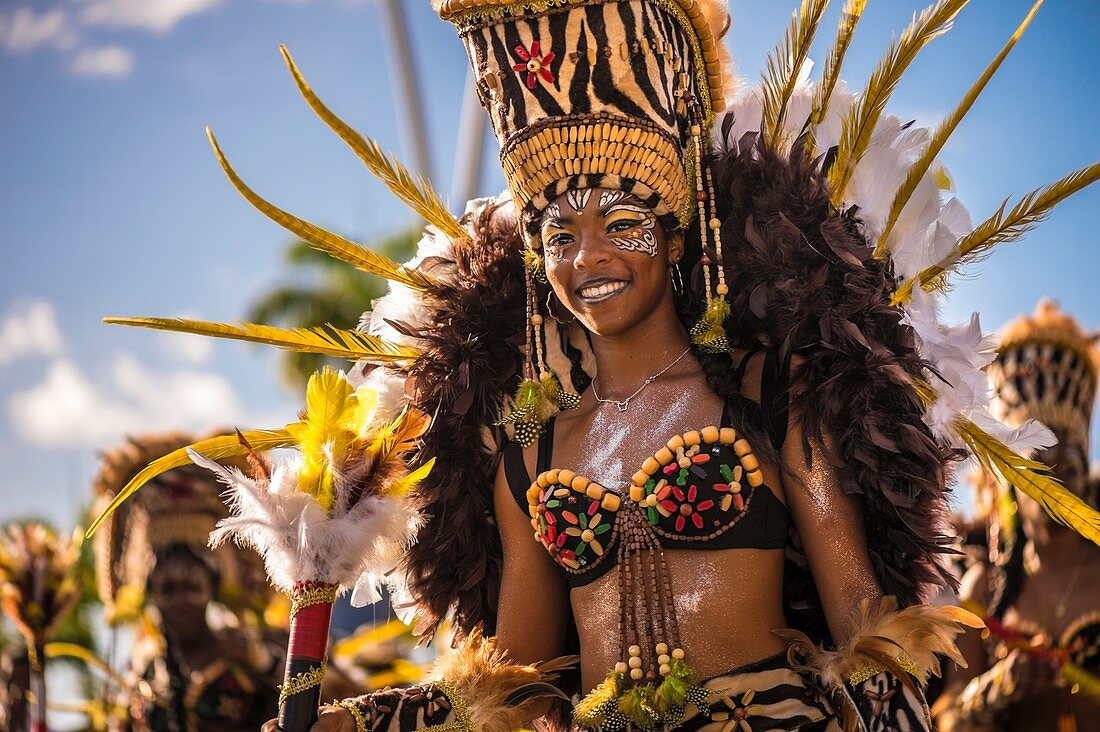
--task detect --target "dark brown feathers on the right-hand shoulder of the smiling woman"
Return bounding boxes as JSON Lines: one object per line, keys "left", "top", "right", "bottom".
{"left": 704, "top": 129, "right": 953, "bottom": 603}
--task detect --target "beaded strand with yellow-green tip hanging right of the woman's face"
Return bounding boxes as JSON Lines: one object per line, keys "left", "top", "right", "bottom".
{"left": 691, "top": 124, "right": 729, "bottom": 353}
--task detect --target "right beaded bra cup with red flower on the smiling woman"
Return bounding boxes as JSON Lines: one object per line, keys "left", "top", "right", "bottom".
{"left": 630, "top": 427, "right": 763, "bottom": 538}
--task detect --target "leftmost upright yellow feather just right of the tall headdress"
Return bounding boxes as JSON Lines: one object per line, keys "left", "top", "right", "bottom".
{"left": 760, "top": 0, "right": 828, "bottom": 148}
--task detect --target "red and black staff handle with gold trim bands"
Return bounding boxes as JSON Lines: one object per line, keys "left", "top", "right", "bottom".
{"left": 278, "top": 582, "right": 337, "bottom": 732}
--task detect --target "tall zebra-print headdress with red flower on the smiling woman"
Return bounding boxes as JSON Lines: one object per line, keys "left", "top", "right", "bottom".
{"left": 436, "top": 0, "right": 728, "bottom": 239}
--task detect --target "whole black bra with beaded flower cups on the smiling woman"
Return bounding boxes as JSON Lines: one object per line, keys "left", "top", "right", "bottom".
{"left": 504, "top": 347, "right": 791, "bottom": 588}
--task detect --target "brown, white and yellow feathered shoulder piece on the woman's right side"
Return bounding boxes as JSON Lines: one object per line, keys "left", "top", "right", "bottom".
{"left": 710, "top": 0, "right": 1100, "bottom": 605}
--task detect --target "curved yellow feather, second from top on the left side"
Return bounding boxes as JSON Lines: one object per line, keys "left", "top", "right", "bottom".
{"left": 207, "top": 128, "right": 436, "bottom": 289}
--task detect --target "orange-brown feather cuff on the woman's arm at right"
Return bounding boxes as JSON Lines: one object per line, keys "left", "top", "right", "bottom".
{"left": 776, "top": 597, "right": 985, "bottom": 691}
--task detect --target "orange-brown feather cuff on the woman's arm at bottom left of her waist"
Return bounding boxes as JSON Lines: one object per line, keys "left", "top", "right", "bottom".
{"left": 427, "top": 630, "right": 579, "bottom": 732}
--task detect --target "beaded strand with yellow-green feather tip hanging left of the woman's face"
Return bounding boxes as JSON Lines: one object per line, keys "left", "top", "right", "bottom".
{"left": 496, "top": 239, "right": 581, "bottom": 447}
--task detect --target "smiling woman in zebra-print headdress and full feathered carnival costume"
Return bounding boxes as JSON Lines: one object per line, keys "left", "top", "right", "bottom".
{"left": 92, "top": 0, "right": 1100, "bottom": 732}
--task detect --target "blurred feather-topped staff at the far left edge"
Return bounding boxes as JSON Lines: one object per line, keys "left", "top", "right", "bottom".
{"left": 0, "top": 524, "right": 80, "bottom": 732}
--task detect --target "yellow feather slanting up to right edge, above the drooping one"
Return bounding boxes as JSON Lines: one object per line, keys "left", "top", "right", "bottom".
{"left": 893, "top": 163, "right": 1100, "bottom": 305}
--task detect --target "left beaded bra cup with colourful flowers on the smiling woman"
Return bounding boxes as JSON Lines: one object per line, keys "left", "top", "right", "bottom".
{"left": 527, "top": 470, "right": 619, "bottom": 571}
